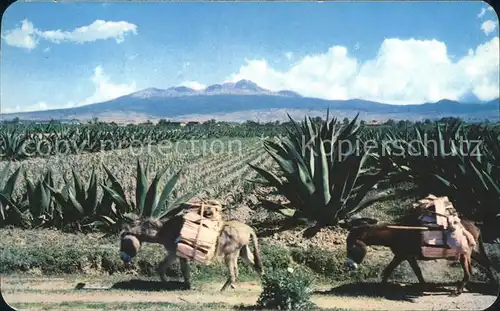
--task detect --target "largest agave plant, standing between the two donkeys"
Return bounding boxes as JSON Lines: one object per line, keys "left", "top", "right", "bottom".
{"left": 249, "top": 114, "right": 387, "bottom": 236}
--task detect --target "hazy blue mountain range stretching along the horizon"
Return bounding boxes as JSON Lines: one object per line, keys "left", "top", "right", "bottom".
{"left": 2, "top": 80, "right": 500, "bottom": 122}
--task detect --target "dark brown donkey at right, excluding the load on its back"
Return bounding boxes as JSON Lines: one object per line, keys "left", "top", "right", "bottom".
{"left": 346, "top": 219, "right": 496, "bottom": 295}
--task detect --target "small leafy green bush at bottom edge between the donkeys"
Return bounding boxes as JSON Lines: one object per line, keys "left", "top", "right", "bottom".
{"left": 257, "top": 268, "right": 314, "bottom": 310}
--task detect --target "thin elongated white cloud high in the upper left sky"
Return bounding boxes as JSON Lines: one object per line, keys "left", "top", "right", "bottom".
{"left": 2, "top": 20, "right": 137, "bottom": 50}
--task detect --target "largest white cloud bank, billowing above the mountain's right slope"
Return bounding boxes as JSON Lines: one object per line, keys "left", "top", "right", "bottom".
{"left": 228, "top": 37, "right": 500, "bottom": 104}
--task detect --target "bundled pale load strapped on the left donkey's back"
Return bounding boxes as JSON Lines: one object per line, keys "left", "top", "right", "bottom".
{"left": 177, "top": 201, "right": 223, "bottom": 264}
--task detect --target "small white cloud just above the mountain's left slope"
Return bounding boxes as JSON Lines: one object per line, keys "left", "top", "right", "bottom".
{"left": 80, "top": 66, "right": 137, "bottom": 106}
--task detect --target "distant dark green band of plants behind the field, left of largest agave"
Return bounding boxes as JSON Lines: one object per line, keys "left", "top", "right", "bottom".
{"left": 0, "top": 122, "right": 283, "bottom": 160}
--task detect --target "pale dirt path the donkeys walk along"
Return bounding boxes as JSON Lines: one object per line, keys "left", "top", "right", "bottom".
{"left": 0, "top": 277, "right": 496, "bottom": 310}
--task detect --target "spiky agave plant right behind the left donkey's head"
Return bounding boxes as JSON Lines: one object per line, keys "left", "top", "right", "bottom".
{"left": 95, "top": 159, "right": 195, "bottom": 231}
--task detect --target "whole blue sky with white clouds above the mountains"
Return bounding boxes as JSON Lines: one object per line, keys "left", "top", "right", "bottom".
{"left": 0, "top": 1, "right": 500, "bottom": 113}
